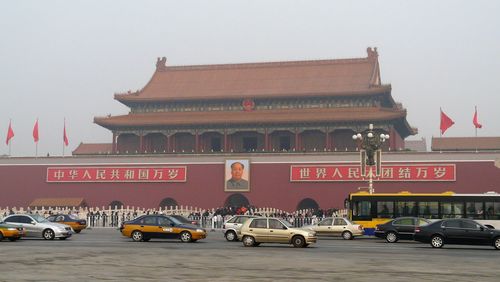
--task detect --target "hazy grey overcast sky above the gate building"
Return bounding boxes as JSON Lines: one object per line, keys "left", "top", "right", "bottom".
{"left": 0, "top": 0, "right": 500, "bottom": 156}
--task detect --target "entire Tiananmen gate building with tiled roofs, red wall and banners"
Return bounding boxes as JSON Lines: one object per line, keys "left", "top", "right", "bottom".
{"left": 0, "top": 48, "right": 500, "bottom": 211}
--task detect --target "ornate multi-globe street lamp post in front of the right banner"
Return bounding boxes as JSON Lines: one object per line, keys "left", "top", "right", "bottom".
{"left": 352, "top": 123, "right": 389, "bottom": 194}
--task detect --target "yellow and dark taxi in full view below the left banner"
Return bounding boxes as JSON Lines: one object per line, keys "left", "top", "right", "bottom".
{"left": 120, "top": 214, "right": 207, "bottom": 243}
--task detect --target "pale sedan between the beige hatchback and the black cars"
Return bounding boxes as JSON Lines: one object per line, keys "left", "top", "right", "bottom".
{"left": 302, "top": 217, "right": 364, "bottom": 240}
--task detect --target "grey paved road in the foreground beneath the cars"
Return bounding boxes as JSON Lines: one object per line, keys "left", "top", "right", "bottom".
{"left": 0, "top": 229, "right": 500, "bottom": 282}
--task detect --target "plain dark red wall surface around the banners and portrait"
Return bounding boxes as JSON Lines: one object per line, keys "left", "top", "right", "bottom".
{"left": 0, "top": 161, "right": 500, "bottom": 211}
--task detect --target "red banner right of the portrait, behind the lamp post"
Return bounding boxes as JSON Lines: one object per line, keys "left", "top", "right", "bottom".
{"left": 290, "top": 164, "right": 456, "bottom": 182}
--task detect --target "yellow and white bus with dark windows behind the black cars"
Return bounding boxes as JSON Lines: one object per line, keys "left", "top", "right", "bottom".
{"left": 346, "top": 191, "right": 500, "bottom": 235}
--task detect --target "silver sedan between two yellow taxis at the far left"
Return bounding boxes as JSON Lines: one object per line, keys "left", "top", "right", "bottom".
{"left": 4, "top": 214, "right": 73, "bottom": 240}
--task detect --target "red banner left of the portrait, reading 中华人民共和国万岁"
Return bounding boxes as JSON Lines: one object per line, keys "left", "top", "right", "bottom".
{"left": 47, "top": 166, "right": 187, "bottom": 183}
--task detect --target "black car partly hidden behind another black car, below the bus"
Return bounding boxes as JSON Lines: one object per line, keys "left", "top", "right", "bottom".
{"left": 375, "top": 217, "right": 431, "bottom": 243}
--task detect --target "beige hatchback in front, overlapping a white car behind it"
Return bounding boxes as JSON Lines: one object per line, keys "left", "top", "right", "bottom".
{"left": 238, "top": 217, "right": 316, "bottom": 248}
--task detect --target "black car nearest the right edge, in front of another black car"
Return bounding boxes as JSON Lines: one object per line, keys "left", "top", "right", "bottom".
{"left": 414, "top": 218, "right": 500, "bottom": 250}
